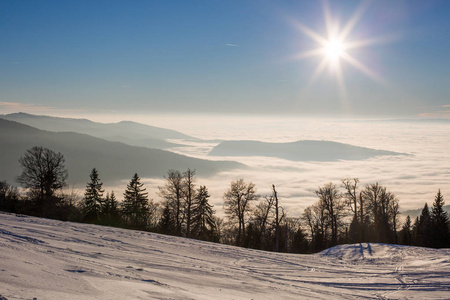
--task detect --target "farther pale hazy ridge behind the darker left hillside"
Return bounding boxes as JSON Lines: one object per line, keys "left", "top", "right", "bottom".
{"left": 0, "top": 113, "right": 197, "bottom": 149}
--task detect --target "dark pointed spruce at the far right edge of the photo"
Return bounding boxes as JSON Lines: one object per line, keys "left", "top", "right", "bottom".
{"left": 431, "top": 190, "right": 449, "bottom": 248}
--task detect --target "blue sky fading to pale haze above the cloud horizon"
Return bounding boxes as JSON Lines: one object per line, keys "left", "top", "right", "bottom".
{"left": 0, "top": 0, "right": 450, "bottom": 118}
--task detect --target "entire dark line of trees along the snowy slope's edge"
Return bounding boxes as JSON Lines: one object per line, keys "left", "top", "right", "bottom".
{"left": 0, "top": 147, "right": 450, "bottom": 253}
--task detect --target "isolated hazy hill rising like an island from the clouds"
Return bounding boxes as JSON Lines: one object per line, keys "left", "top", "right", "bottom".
{"left": 208, "top": 141, "right": 403, "bottom": 161}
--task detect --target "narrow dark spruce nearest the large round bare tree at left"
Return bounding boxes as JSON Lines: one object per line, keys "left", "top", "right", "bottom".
{"left": 83, "top": 168, "right": 104, "bottom": 222}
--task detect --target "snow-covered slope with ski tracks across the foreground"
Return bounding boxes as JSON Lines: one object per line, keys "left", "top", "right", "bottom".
{"left": 0, "top": 214, "right": 450, "bottom": 300}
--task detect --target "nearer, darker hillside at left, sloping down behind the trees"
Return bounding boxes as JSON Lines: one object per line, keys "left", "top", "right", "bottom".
{"left": 0, "top": 118, "right": 244, "bottom": 183}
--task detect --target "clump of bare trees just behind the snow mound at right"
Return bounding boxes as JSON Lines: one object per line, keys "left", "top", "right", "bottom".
{"left": 302, "top": 178, "right": 399, "bottom": 250}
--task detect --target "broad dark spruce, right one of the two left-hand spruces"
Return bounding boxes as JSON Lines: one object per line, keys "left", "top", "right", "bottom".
{"left": 122, "top": 173, "right": 149, "bottom": 229}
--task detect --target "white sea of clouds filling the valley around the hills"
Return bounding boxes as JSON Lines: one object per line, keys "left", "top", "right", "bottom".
{"left": 103, "top": 115, "right": 450, "bottom": 217}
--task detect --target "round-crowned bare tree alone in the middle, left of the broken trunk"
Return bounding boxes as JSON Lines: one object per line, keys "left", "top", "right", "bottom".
{"left": 223, "top": 179, "right": 258, "bottom": 245}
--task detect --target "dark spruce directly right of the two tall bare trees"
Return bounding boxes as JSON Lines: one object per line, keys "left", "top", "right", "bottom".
{"left": 192, "top": 186, "right": 216, "bottom": 240}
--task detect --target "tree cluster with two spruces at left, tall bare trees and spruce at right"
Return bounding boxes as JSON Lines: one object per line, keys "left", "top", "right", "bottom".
{"left": 79, "top": 168, "right": 218, "bottom": 241}
